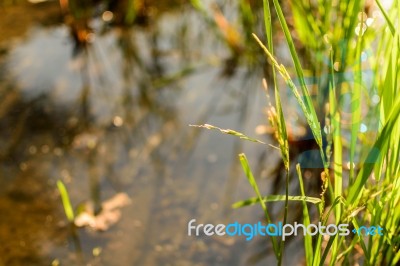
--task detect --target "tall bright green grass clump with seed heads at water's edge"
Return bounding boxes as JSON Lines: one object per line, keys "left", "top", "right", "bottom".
{"left": 195, "top": 0, "right": 400, "bottom": 265}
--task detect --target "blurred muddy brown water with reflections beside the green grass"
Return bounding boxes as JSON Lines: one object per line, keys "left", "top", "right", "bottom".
{"left": 0, "top": 2, "right": 301, "bottom": 265}
